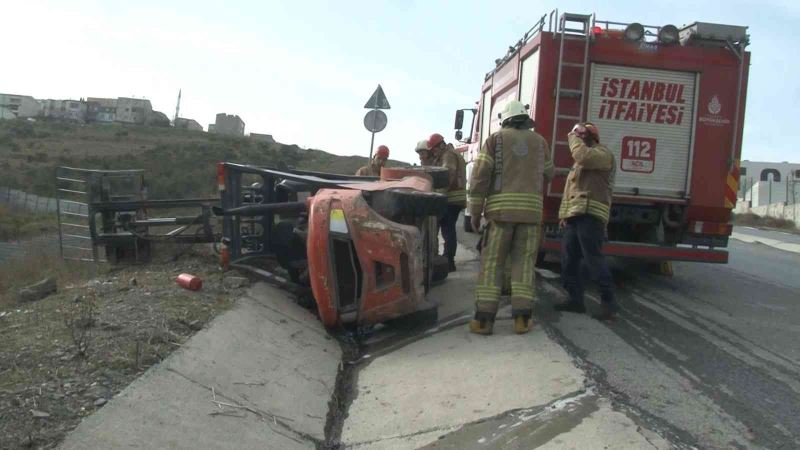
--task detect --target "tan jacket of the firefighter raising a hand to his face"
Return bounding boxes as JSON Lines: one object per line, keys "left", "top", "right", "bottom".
{"left": 558, "top": 133, "right": 616, "bottom": 223}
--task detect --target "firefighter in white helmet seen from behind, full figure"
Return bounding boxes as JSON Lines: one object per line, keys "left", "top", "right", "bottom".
{"left": 469, "top": 101, "right": 554, "bottom": 334}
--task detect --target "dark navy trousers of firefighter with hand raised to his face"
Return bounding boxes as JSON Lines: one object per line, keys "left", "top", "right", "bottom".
{"left": 561, "top": 214, "right": 617, "bottom": 311}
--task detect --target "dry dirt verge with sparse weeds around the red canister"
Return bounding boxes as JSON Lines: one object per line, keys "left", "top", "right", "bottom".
{"left": 0, "top": 251, "right": 248, "bottom": 449}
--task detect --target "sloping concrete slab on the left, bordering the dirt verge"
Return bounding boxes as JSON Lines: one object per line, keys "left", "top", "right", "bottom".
{"left": 62, "top": 283, "right": 341, "bottom": 449}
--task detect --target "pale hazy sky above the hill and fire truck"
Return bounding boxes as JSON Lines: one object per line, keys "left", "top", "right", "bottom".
{"left": 0, "top": 0, "right": 800, "bottom": 162}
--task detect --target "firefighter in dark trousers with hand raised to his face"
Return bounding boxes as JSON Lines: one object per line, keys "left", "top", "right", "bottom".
{"left": 555, "top": 123, "right": 618, "bottom": 320}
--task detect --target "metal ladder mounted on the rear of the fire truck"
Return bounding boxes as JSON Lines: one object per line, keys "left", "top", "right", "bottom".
{"left": 550, "top": 13, "right": 594, "bottom": 174}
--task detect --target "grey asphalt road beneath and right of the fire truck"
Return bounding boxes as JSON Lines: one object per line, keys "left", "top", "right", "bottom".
{"left": 461, "top": 223, "right": 800, "bottom": 449}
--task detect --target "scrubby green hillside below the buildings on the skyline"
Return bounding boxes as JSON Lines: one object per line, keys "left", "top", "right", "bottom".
{"left": 0, "top": 120, "right": 399, "bottom": 198}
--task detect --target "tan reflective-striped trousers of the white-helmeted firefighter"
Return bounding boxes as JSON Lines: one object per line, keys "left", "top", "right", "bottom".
{"left": 475, "top": 221, "right": 541, "bottom": 315}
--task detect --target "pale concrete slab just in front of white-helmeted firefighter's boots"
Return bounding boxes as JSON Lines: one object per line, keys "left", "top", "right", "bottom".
{"left": 342, "top": 320, "right": 584, "bottom": 445}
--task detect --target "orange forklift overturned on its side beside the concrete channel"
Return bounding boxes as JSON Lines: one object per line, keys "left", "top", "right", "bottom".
{"left": 214, "top": 163, "right": 448, "bottom": 327}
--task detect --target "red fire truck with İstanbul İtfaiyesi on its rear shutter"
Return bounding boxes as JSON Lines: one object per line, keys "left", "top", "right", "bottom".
{"left": 455, "top": 10, "right": 750, "bottom": 263}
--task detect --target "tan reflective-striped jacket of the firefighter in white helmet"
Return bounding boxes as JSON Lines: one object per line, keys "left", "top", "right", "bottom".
{"left": 469, "top": 128, "right": 553, "bottom": 223}
